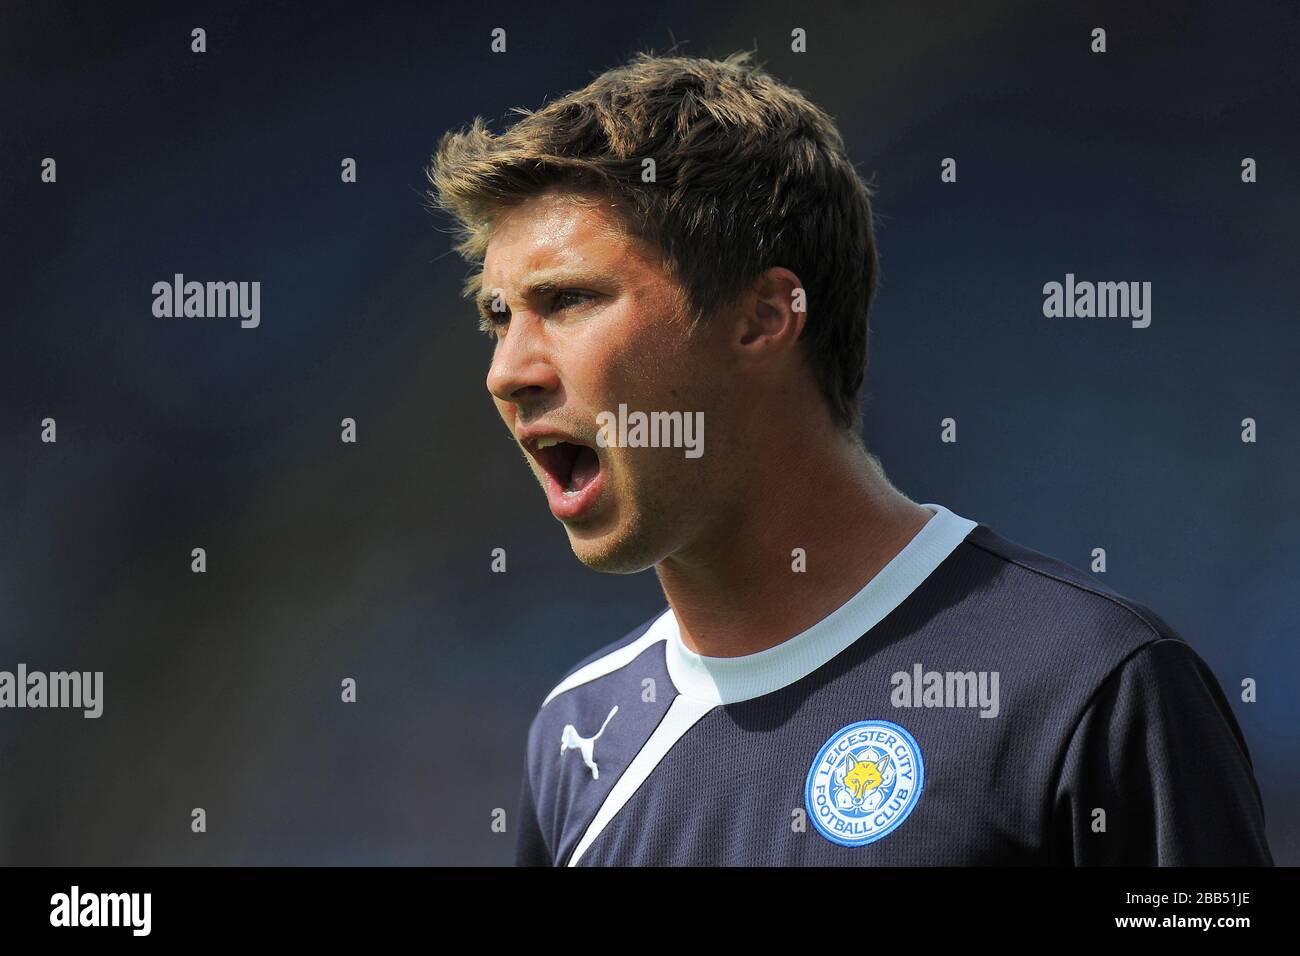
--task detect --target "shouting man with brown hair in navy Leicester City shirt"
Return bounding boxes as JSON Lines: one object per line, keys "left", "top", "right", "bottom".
{"left": 429, "top": 53, "right": 1271, "bottom": 866}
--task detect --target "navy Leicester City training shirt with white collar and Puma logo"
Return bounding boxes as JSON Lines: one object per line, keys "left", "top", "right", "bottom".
{"left": 516, "top": 505, "right": 1273, "bottom": 866}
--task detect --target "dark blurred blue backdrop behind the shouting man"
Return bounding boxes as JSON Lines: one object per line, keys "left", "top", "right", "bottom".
{"left": 0, "top": 0, "right": 1300, "bottom": 865}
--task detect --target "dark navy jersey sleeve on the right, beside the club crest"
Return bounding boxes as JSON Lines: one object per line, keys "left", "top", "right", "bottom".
{"left": 1052, "top": 639, "right": 1273, "bottom": 866}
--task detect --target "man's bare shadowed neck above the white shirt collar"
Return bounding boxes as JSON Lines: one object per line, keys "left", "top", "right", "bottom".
{"left": 655, "top": 433, "right": 933, "bottom": 657}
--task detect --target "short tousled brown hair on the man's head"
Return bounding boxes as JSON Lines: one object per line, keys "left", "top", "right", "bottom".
{"left": 426, "top": 51, "right": 879, "bottom": 432}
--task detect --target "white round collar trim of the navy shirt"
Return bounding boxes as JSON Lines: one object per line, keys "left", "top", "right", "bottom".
{"left": 655, "top": 503, "right": 978, "bottom": 704}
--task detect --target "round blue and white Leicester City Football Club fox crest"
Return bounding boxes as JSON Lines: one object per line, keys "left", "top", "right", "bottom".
{"left": 803, "top": 721, "right": 926, "bottom": 847}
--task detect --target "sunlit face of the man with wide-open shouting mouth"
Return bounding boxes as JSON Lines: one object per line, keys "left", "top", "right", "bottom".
{"left": 481, "top": 191, "right": 729, "bottom": 574}
